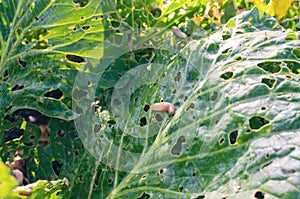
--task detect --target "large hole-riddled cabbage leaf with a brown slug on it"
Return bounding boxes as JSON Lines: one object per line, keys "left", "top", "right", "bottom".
{"left": 74, "top": 9, "right": 300, "bottom": 198}
